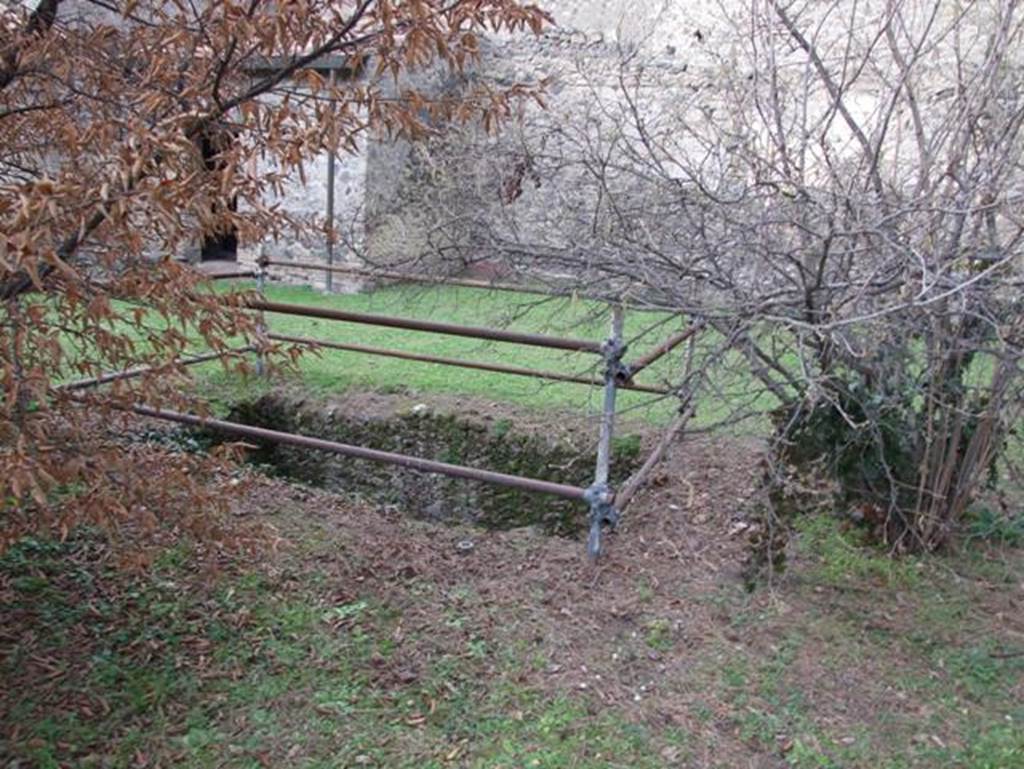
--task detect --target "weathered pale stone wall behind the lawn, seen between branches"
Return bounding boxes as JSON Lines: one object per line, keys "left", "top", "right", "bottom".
{"left": 247, "top": 0, "right": 1020, "bottom": 288}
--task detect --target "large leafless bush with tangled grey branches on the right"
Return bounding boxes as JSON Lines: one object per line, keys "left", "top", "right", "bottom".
{"left": 403, "top": 0, "right": 1024, "bottom": 550}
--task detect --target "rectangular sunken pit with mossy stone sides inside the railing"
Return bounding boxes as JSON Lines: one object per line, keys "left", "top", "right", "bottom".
{"left": 229, "top": 392, "right": 640, "bottom": 536}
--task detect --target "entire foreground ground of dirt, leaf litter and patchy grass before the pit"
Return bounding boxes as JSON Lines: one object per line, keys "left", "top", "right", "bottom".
{"left": 0, "top": 393, "right": 1024, "bottom": 768}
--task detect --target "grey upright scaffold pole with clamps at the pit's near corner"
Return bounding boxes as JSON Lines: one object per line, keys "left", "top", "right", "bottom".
{"left": 585, "top": 305, "right": 626, "bottom": 560}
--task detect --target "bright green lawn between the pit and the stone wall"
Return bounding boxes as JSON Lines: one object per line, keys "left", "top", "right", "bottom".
{"left": 41, "top": 281, "right": 775, "bottom": 434}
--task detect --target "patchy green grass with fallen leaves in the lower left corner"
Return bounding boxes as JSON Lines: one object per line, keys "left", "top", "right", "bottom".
{"left": 0, "top": 540, "right": 675, "bottom": 768}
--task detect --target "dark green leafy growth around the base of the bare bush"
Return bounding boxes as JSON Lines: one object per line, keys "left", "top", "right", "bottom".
{"left": 768, "top": 391, "right": 1005, "bottom": 552}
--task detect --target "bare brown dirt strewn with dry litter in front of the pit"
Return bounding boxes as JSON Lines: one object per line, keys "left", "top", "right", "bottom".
{"left": 232, "top": 430, "right": 1024, "bottom": 769}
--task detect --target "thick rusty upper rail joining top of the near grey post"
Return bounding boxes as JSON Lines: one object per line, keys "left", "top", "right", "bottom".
{"left": 247, "top": 299, "right": 601, "bottom": 353}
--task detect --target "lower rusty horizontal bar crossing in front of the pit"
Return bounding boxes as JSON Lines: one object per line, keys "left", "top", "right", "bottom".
{"left": 131, "top": 405, "right": 587, "bottom": 500}
